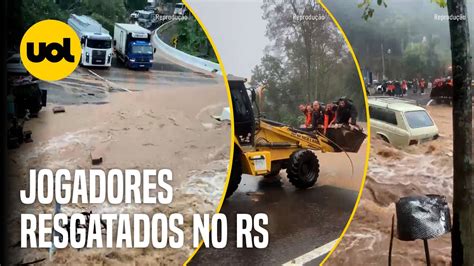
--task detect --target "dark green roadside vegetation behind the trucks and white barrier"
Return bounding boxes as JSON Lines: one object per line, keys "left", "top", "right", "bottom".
{"left": 9, "top": 0, "right": 217, "bottom": 63}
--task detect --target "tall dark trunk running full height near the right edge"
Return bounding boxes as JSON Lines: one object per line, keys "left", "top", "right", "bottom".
{"left": 447, "top": 0, "right": 474, "bottom": 266}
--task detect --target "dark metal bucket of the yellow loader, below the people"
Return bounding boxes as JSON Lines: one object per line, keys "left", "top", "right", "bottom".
{"left": 326, "top": 126, "right": 367, "bottom": 153}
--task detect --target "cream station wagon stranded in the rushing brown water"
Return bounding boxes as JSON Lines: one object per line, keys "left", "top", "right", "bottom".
{"left": 368, "top": 97, "right": 439, "bottom": 147}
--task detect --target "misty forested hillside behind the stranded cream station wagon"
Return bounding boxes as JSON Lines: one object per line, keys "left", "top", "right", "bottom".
{"left": 326, "top": 0, "right": 474, "bottom": 80}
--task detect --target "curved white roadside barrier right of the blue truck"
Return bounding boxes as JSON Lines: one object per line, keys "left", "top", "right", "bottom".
{"left": 153, "top": 20, "right": 222, "bottom": 75}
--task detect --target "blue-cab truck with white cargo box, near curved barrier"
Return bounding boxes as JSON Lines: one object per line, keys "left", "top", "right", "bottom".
{"left": 114, "top": 23, "right": 156, "bottom": 70}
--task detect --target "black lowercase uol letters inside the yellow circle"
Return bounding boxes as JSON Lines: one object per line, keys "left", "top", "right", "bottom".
{"left": 26, "top": 38, "right": 74, "bottom": 63}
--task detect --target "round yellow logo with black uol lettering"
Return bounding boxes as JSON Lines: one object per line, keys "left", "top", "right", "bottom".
{"left": 20, "top": 20, "right": 81, "bottom": 81}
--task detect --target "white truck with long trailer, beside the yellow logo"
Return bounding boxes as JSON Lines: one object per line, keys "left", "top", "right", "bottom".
{"left": 67, "top": 14, "right": 113, "bottom": 67}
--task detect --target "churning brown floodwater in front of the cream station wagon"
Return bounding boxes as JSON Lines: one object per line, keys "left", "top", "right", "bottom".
{"left": 328, "top": 105, "right": 462, "bottom": 265}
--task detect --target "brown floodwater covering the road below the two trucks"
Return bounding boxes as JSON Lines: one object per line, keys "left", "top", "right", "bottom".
{"left": 8, "top": 68, "right": 230, "bottom": 265}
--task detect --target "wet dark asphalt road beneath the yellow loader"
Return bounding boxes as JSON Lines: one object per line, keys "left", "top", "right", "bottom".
{"left": 191, "top": 174, "right": 357, "bottom": 265}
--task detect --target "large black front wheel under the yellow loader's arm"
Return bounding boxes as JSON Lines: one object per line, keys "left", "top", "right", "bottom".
{"left": 286, "top": 150, "right": 319, "bottom": 188}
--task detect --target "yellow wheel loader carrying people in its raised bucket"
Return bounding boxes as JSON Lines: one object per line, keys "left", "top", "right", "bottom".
{"left": 226, "top": 75, "right": 366, "bottom": 198}
